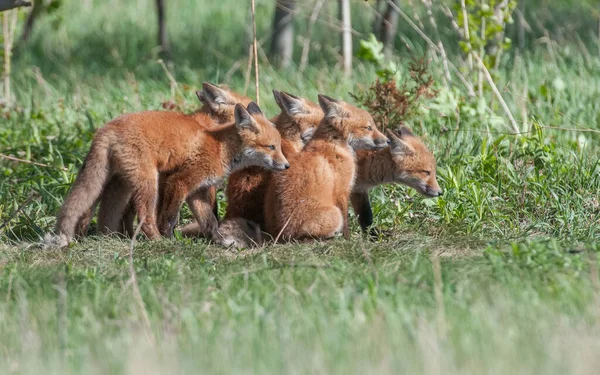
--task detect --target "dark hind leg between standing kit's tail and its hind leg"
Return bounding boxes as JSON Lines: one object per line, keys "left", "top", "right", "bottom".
{"left": 98, "top": 175, "right": 131, "bottom": 234}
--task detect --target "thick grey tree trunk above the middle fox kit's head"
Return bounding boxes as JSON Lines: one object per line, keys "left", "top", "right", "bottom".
{"left": 271, "top": 0, "right": 296, "bottom": 68}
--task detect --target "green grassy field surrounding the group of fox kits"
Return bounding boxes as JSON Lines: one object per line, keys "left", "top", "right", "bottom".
{"left": 0, "top": 0, "right": 600, "bottom": 374}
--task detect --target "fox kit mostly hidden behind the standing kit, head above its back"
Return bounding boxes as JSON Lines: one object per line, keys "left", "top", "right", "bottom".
{"left": 76, "top": 82, "right": 252, "bottom": 236}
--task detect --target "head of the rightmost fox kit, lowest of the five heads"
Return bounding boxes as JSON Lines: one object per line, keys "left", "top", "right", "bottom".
{"left": 387, "top": 126, "right": 442, "bottom": 198}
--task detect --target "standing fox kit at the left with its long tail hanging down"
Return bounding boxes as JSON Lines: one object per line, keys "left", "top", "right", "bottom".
{"left": 49, "top": 102, "right": 289, "bottom": 244}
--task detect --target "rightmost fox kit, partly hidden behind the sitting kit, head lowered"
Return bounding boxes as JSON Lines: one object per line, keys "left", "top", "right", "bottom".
{"left": 350, "top": 126, "right": 442, "bottom": 235}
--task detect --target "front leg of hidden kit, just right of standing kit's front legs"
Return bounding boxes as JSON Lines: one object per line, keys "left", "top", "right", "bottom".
{"left": 181, "top": 186, "right": 219, "bottom": 238}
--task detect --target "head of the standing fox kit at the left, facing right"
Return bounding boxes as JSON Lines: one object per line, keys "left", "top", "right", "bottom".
{"left": 235, "top": 102, "right": 290, "bottom": 171}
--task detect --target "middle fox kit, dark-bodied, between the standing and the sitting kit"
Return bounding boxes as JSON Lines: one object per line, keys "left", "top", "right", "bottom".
{"left": 182, "top": 90, "right": 323, "bottom": 247}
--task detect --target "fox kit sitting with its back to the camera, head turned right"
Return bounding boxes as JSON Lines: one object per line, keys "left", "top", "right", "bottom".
{"left": 265, "top": 95, "right": 388, "bottom": 240}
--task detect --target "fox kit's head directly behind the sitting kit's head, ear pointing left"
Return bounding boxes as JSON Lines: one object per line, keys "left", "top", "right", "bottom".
{"left": 273, "top": 90, "right": 323, "bottom": 149}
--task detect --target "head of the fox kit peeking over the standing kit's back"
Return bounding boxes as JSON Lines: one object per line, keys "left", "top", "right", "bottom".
{"left": 196, "top": 82, "right": 252, "bottom": 124}
